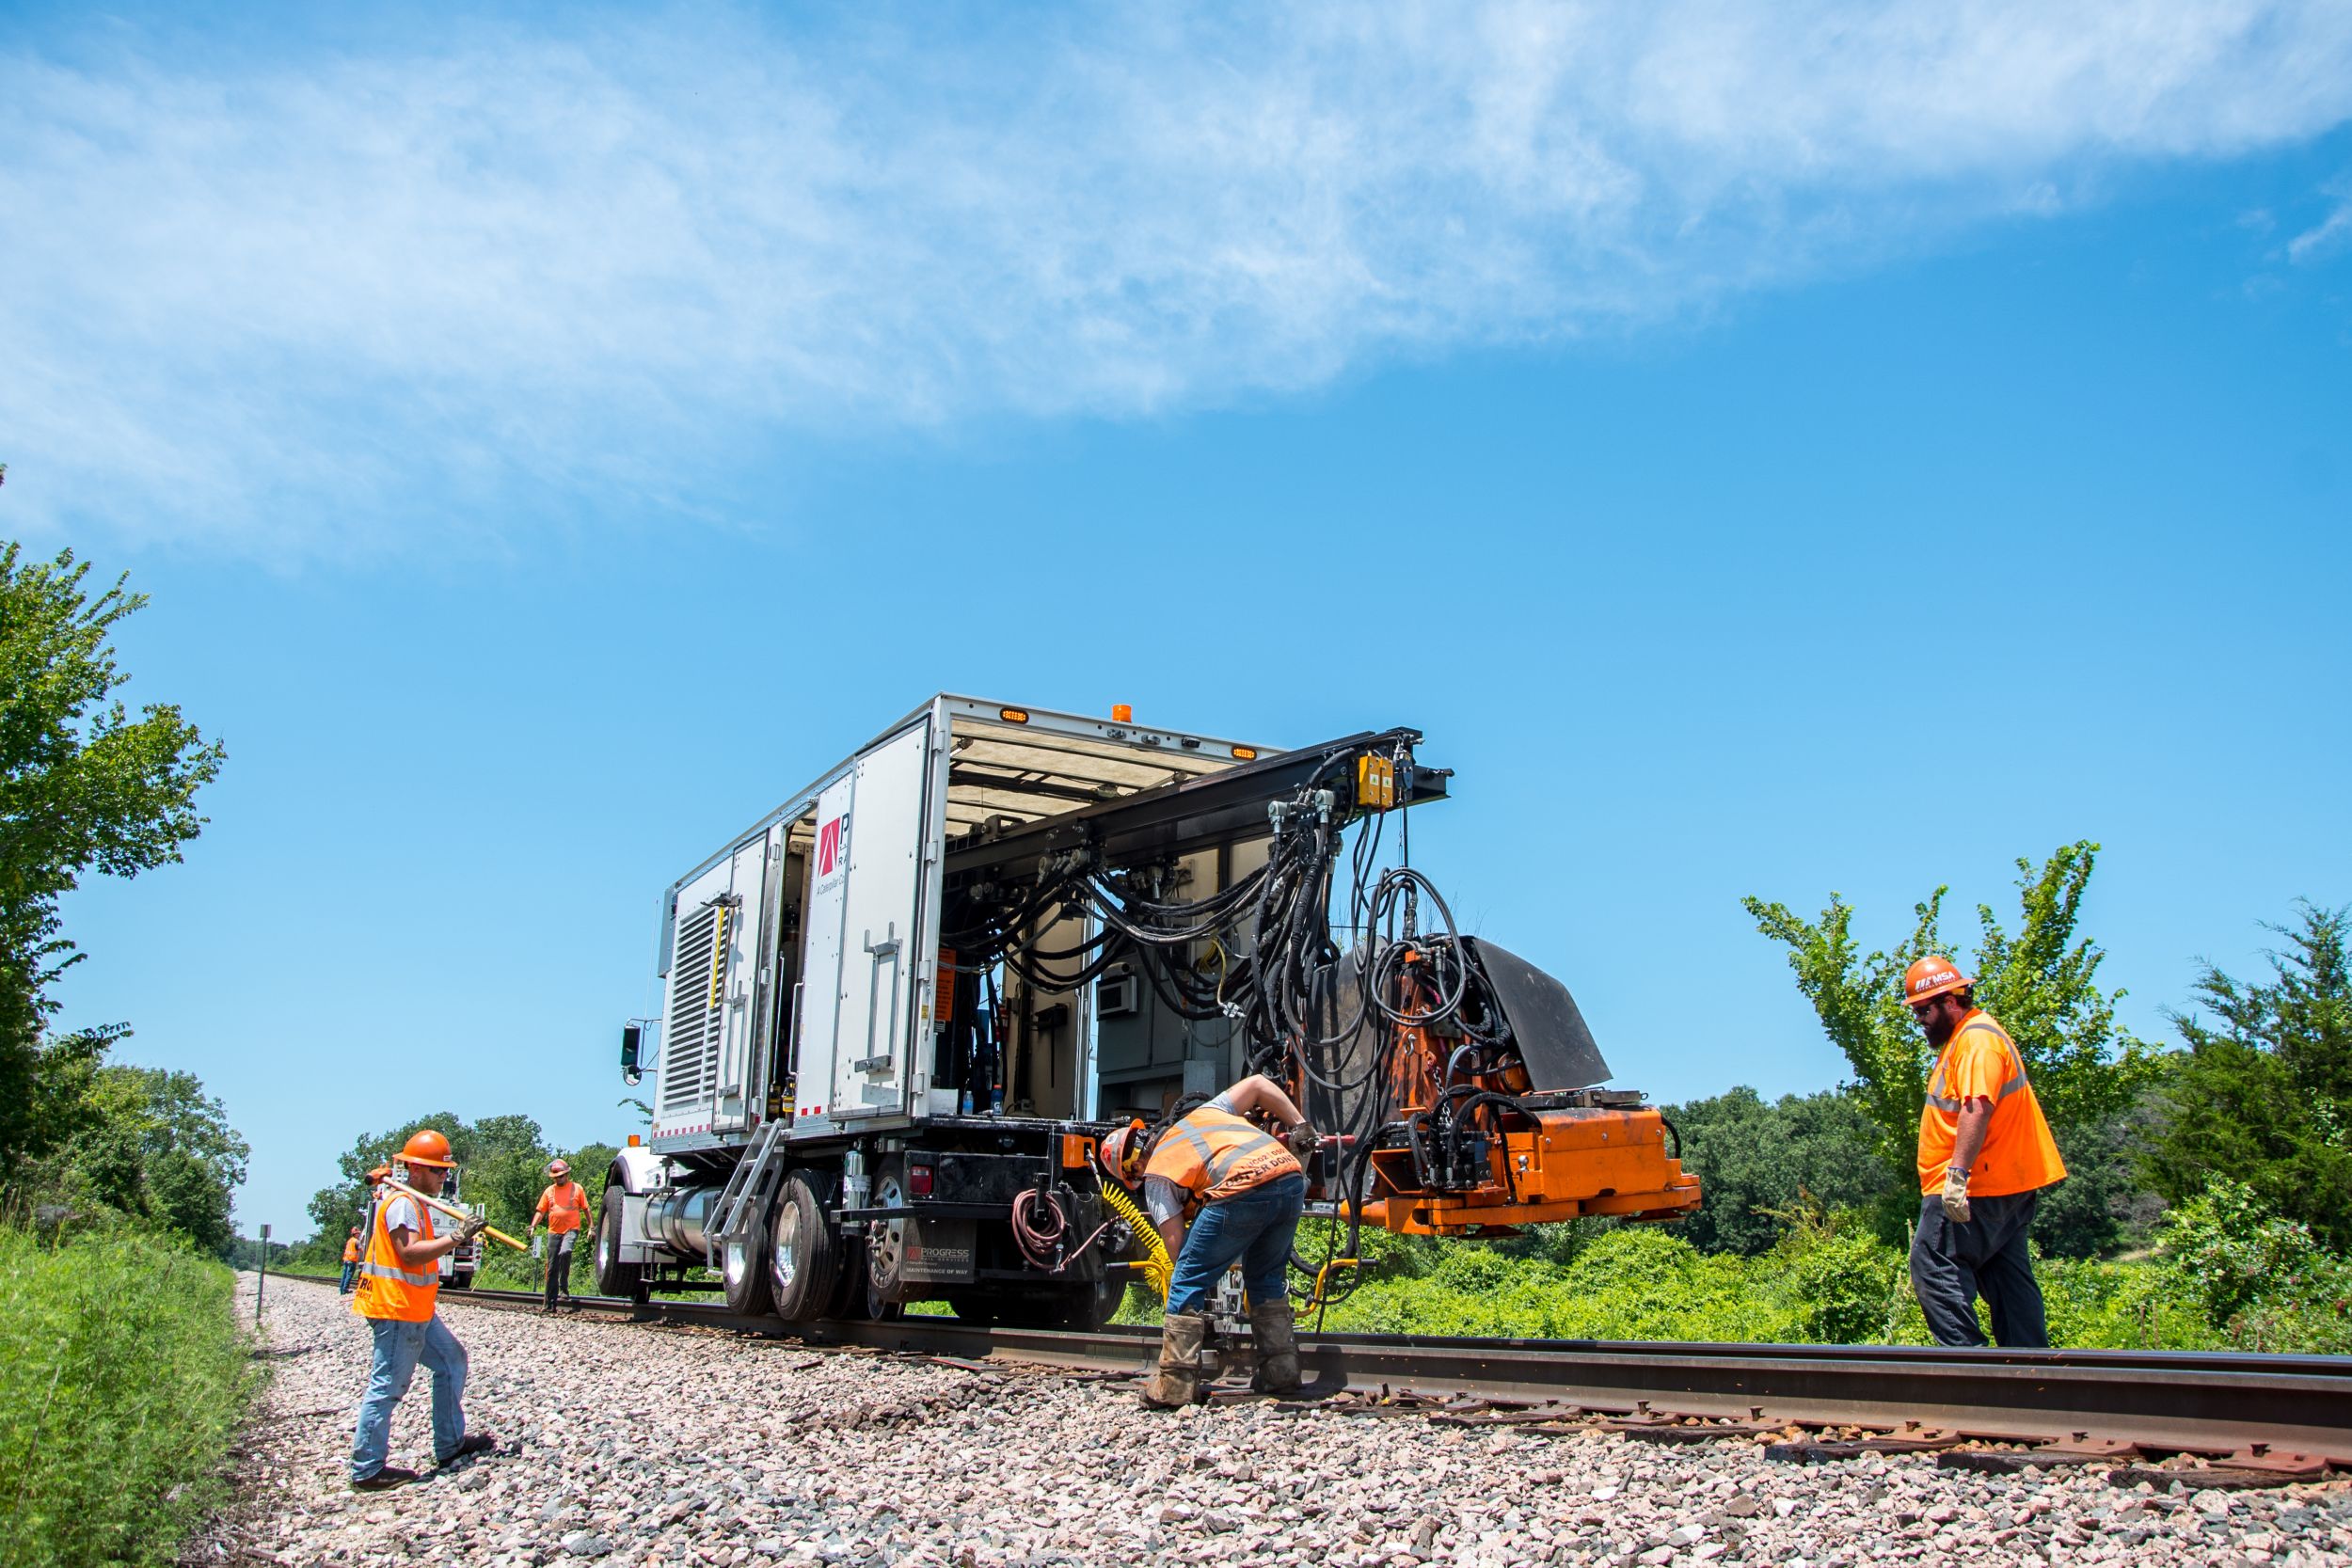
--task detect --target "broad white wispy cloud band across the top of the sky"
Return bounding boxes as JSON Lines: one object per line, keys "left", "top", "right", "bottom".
{"left": 0, "top": 0, "right": 2352, "bottom": 552}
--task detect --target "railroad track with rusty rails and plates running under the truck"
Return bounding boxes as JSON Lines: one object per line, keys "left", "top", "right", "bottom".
{"left": 279, "top": 1291, "right": 2352, "bottom": 1486}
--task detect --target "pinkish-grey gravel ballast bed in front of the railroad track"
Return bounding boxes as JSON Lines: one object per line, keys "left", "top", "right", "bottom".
{"left": 221, "top": 1276, "right": 2352, "bottom": 1568}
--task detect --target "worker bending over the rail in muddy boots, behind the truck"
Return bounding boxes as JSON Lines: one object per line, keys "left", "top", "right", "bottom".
{"left": 1101, "top": 1074, "right": 1317, "bottom": 1411}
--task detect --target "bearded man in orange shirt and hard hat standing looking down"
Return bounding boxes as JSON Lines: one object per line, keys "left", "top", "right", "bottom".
{"left": 1903, "top": 952, "right": 2065, "bottom": 1347}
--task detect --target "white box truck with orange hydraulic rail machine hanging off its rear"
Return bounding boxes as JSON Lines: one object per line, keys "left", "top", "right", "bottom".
{"left": 596, "top": 696, "right": 1698, "bottom": 1326}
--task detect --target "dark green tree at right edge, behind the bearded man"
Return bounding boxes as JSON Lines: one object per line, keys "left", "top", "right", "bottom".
{"left": 2145, "top": 903, "right": 2352, "bottom": 1248}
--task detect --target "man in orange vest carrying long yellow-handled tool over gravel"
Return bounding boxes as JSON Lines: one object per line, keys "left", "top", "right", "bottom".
{"left": 351, "top": 1129, "right": 497, "bottom": 1493}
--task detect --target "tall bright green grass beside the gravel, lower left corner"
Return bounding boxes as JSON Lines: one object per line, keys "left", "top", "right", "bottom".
{"left": 0, "top": 1227, "right": 259, "bottom": 1568}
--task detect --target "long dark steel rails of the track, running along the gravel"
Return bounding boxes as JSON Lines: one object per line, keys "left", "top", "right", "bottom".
{"left": 279, "top": 1291, "right": 2352, "bottom": 1467}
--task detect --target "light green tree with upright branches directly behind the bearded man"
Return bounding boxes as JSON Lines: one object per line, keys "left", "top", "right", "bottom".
{"left": 1743, "top": 839, "right": 2157, "bottom": 1231}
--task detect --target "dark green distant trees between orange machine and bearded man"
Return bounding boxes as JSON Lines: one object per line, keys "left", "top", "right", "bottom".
{"left": 1665, "top": 1084, "right": 1910, "bottom": 1256}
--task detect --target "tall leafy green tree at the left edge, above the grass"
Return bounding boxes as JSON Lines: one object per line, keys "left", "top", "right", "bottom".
{"left": 0, "top": 543, "right": 226, "bottom": 1182}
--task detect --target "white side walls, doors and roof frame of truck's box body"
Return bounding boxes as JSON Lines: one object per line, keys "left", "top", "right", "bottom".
{"left": 630, "top": 696, "right": 1275, "bottom": 1161}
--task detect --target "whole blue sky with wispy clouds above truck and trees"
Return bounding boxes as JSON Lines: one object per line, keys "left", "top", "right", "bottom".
{"left": 0, "top": 2, "right": 2352, "bottom": 1234}
